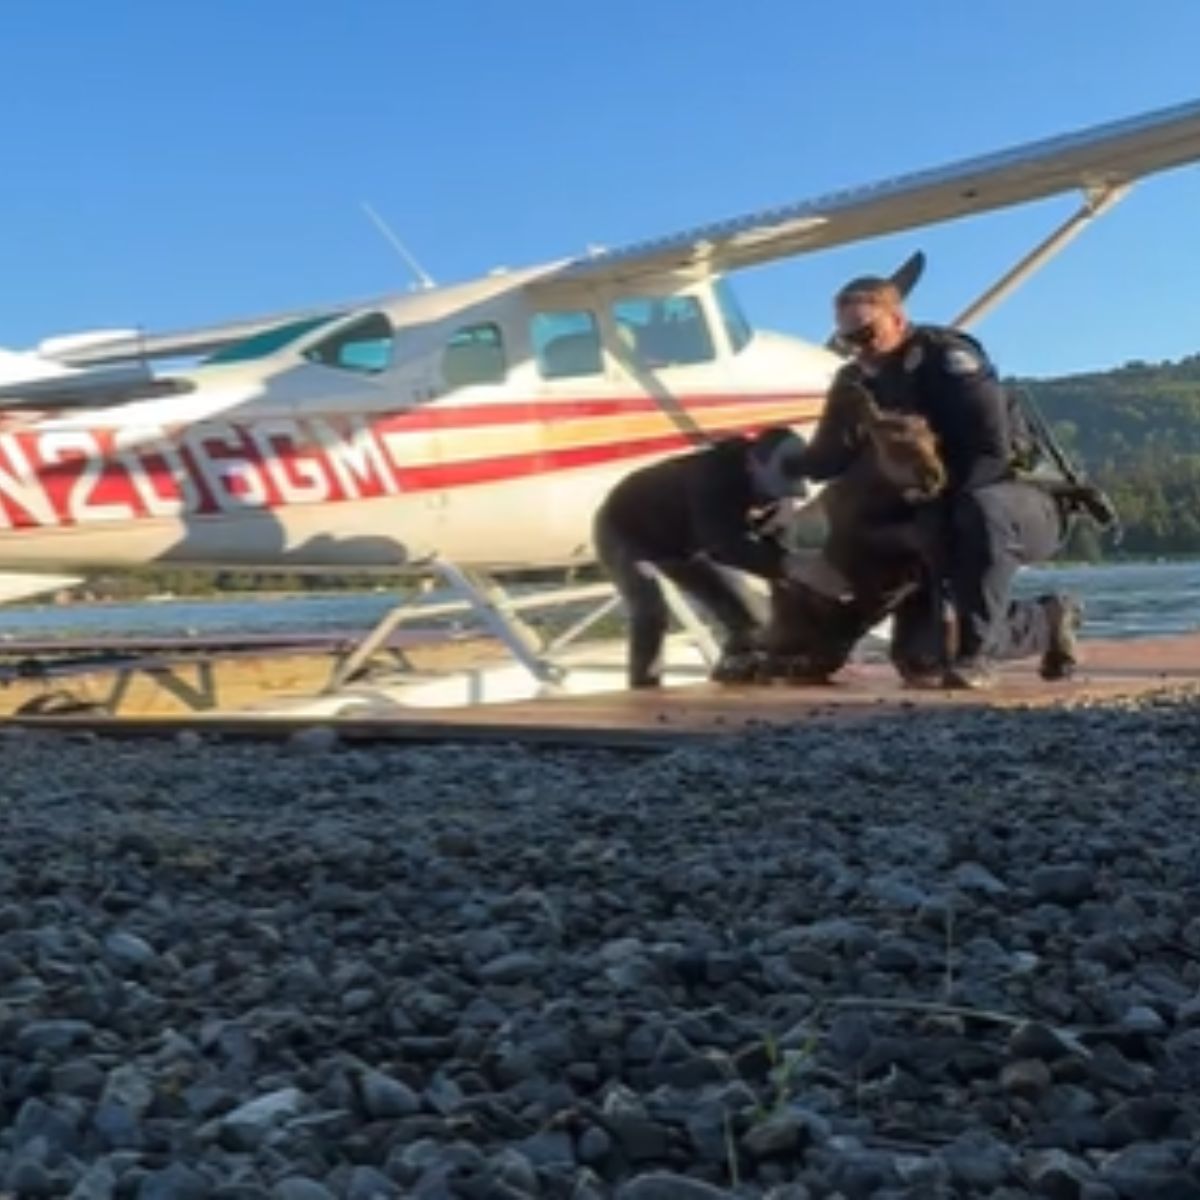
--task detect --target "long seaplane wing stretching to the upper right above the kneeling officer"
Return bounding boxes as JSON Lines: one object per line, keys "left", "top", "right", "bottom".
{"left": 558, "top": 101, "right": 1200, "bottom": 278}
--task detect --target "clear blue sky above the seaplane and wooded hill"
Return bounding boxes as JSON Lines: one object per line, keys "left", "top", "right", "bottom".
{"left": 0, "top": 0, "right": 1200, "bottom": 374}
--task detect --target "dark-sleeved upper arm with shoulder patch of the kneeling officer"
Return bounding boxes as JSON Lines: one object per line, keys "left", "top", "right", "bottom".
{"left": 923, "top": 342, "right": 1013, "bottom": 492}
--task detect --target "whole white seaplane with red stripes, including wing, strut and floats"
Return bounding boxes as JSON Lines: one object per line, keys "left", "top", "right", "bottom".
{"left": 0, "top": 101, "right": 1200, "bottom": 712}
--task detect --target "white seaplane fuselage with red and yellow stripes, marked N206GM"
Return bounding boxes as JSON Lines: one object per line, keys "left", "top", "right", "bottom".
{"left": 0, "top": 276, "right": 840, "bottom": 571}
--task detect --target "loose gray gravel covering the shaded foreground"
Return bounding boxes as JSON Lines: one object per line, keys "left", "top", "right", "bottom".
{"left": 7, "top": 697, "right": 1200, "bottom": 1200}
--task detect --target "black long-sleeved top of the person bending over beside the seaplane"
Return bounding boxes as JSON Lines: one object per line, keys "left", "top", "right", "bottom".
{"left": 604, "top": 438, "right": 784, "bottom": 578}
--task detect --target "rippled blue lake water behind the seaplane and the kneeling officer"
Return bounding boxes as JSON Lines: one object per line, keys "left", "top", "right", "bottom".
{"left": 0, "top": 563, "right": 1200, "bottom": 638}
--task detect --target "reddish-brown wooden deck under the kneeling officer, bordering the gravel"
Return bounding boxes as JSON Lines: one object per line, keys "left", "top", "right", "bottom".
{"left": 5, "top": 634, "right": 1200, "bottom": 749}
